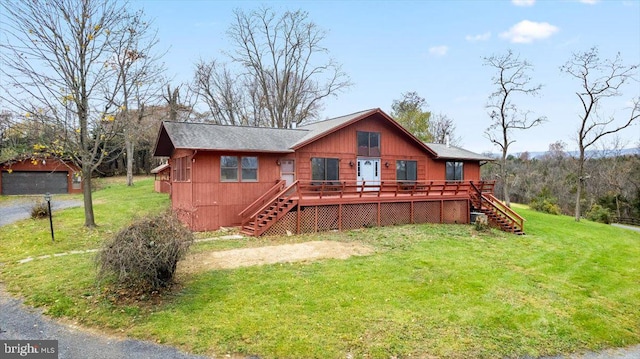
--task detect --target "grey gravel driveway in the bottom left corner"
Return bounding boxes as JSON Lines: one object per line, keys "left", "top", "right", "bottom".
{"left": 0, "top": 286, "right": 205, "bottom": 359}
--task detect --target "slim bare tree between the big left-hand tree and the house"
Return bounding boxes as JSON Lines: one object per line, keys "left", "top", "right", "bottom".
{"left": 107, "top": 11, "right": 164, "bottom": 186}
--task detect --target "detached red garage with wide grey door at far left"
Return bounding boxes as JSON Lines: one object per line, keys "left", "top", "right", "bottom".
{"left": 0, "top": 158, "right": 82, "bottom": 195}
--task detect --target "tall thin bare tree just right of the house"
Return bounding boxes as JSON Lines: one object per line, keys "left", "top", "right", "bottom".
{"left": 484, "top": 50, "right": 546, "bottom": 206}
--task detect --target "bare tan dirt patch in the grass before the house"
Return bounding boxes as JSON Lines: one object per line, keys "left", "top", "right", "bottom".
{"left": 178, "top": 241, "right": 374, "bottom": 273}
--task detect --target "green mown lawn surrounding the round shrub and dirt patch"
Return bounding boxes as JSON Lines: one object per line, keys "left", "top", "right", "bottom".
{"left": 0, "top": 181, "right": 640, "bottom": 358}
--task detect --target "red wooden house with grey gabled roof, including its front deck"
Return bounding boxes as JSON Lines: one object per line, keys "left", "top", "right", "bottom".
{"left": 154, "top": 109, "right": 523, "bottom": 235}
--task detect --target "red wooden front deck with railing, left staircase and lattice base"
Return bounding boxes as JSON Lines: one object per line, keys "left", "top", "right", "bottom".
{"left": 239, "top": 181, "right": 504, "bottom": 236}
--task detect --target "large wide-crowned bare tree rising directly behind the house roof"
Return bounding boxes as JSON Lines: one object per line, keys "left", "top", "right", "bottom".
{"left": 222, "top": 8, "right": 350, "bottom": 128}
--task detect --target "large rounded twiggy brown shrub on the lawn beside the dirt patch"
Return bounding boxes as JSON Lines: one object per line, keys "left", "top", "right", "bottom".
{"left": 98, "top": 213, "right": 193, "bottom": 291}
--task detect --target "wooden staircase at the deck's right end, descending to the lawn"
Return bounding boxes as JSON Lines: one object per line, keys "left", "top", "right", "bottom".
{"left": 470, "top": 182, "right": 525, "bottom": 235}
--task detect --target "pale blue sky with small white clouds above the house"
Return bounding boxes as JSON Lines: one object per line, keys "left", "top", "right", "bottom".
{"left": 132, "top": 0, "right": 640, "bottom": 153}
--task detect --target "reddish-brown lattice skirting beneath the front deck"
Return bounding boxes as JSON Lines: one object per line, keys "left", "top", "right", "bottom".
{"left": 264, "top": 200, "right": 469, "bottom": 235}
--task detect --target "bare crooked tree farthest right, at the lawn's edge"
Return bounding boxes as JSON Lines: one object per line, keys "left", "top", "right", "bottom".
{"left": 560, "top": 47, "right": 640, "bottom": 221}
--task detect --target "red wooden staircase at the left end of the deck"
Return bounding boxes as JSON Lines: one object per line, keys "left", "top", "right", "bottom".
{"left": 240, "top": 181, "right": 298, "bottom": 237}
